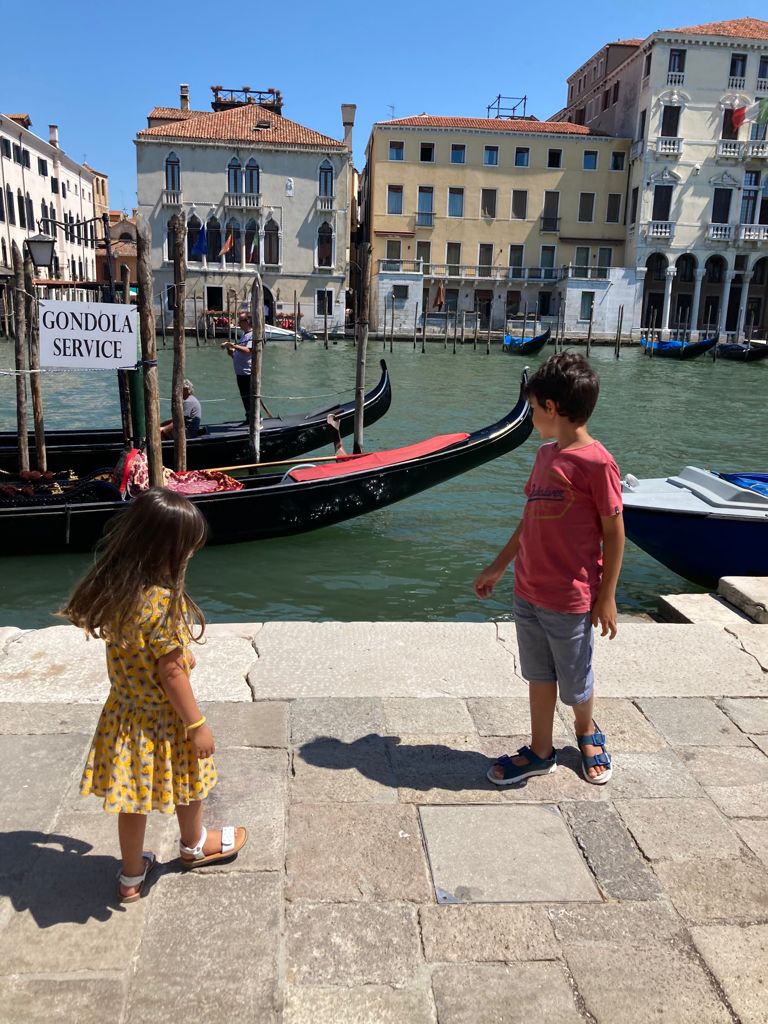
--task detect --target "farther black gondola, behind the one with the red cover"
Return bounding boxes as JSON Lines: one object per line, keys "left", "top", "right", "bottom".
{"left": 0, "top": 359, "right": 392, "bottom": 476}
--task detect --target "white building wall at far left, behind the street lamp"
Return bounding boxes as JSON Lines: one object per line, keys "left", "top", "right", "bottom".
{"left": 0, "top": 115, "right": 96, "bottom": 300}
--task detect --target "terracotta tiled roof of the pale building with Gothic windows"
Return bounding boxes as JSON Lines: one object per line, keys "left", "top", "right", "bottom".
{"left": 137, "top": 103, "right": 344, "bottom": 150}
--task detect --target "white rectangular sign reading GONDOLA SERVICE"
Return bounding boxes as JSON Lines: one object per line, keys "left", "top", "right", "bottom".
{"left": 40, "top": 299, "right": 138, "bottom": 370}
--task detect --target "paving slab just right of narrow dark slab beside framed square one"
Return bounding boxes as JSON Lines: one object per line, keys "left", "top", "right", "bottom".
{"left": 615, "top": 799, "right": 743, "bottom": 860}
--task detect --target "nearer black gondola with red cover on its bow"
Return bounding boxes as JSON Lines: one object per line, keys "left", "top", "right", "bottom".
{"left": 0, "top": 372, "right": 531, "bottom": 555}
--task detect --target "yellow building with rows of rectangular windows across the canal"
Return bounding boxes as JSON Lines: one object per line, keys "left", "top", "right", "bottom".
{"left": 361, "top": 115, "right": 635, "bottom": 331}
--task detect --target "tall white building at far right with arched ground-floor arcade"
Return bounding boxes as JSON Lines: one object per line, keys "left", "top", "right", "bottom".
{"left": 553, "top": 17, "right": 768, "bottom": 337}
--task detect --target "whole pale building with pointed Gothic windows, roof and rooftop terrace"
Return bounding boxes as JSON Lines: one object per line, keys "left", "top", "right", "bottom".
{"left": 136, "top": 85, "right": 355, "bottom": 330}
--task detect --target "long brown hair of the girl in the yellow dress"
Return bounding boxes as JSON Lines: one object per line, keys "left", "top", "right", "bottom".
{"left": 59, "top": 487, "right": 208, "bottom": 643}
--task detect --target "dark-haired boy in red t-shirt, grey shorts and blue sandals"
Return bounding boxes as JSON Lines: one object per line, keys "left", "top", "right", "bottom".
{"left": 474, "top": 352, "right": 624, "bottom": 785}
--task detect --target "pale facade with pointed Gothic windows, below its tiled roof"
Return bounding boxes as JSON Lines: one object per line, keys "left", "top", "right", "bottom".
{"left": 136, "top": 137, "right": 351, "bottom": 331}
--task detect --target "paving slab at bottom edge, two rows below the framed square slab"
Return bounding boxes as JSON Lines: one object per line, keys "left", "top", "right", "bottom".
{"left": 432, "top": 963, "right": 583, "bottom": 1024}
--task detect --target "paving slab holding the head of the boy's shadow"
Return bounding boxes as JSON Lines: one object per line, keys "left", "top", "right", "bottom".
{"left": 290, "top": 735, "right": 397, "bottom": 804}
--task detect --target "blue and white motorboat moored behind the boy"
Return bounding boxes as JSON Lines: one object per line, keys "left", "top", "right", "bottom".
{"left": 622, "top": 466, "right": 768, "bottom": 587}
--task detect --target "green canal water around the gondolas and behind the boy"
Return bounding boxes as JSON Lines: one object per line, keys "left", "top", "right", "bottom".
{"left": 0, "top": 341, "right": 768, "bottom": 628}
